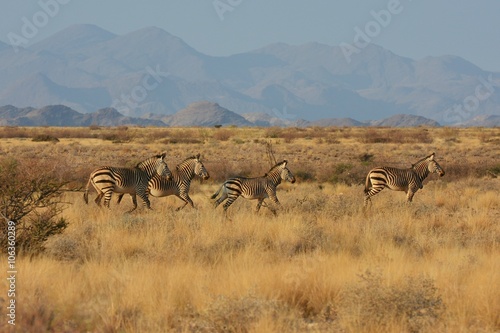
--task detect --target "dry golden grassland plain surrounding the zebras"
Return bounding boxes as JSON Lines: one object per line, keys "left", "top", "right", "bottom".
{"left": 0, "top": 127, "right": 500, "bottom": 332}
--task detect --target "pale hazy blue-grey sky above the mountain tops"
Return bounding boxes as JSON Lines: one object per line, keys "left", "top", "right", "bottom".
{"left": 0, "top": 0, "right": 500, "bottom": 72}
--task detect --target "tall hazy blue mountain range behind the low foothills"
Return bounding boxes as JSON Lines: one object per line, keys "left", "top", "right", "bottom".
{"left": 0, "top": 25, "right": 500, "bottom": 125}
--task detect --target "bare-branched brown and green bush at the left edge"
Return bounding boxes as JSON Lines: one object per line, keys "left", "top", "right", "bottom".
{"left": 0, "top": 158, "right": 67, "bottom": 254}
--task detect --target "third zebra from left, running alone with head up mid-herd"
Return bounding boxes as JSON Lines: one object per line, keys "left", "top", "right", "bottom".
{"left": 211, "top": 160, "right": 295, "bottom": 213}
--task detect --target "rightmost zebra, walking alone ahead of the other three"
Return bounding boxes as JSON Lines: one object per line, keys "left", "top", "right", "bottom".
{"left": 364, "top": 153, "right": 444, "bottom": 207}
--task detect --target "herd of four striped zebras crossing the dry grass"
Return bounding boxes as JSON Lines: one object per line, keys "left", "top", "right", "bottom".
{"left": 83, "top": 153, "right": 445, "bottom": 214}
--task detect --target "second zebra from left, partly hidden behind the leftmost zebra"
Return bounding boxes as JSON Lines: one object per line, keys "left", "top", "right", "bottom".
{"left": 117, "top": 154, "right": 210, "bottom": 211}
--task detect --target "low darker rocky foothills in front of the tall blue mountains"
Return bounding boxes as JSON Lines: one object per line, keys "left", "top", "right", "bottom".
{"left": 0, "top": 101, "right": 454, "bottom": 127}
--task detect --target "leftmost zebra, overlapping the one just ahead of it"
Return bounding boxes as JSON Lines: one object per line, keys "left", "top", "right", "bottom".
{"left": 83, "top": 153, "right": 172, "bottom": 212}
